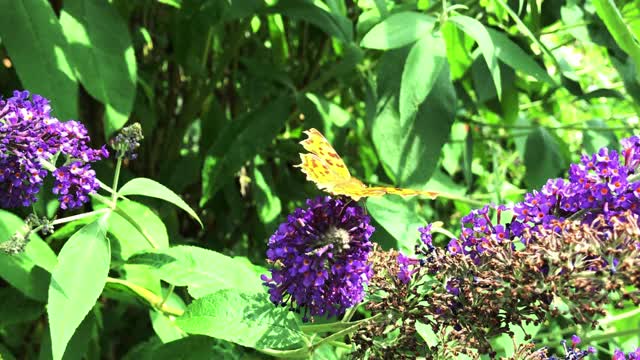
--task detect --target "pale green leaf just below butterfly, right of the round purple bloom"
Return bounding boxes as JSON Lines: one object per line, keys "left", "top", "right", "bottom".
{"left": 367, "top": 196, "right": 427, "bottom": 254}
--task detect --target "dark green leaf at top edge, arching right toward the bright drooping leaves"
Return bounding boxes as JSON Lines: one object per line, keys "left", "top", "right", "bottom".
{"left": 268, "top": 0, "right": 353, "bottom": 43}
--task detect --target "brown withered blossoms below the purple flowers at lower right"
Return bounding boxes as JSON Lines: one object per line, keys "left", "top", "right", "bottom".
{"left": 353, "top": 212, "right": 640, "bottom": 359}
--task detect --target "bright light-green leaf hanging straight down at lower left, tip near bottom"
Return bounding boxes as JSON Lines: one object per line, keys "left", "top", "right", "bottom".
{"left": 47, "top": 215, "right": 111, "bottom": 360}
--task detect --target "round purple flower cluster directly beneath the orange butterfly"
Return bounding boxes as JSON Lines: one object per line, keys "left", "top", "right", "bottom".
{"left": 262, "top": 196, "right": 374, "bottom": 321}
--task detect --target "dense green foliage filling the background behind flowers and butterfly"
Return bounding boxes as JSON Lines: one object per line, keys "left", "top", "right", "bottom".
{"left": 0, "top": 0, "right": 640, "bottom": 359}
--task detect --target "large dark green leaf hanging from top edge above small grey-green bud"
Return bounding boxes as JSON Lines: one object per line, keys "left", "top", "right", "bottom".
{"left": 60, "top": 0, "right": 137, "bottom": 138}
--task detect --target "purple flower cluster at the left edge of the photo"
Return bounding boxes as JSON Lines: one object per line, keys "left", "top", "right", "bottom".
{"left": 0, "top": 91, "right": 109, "bottom": 209}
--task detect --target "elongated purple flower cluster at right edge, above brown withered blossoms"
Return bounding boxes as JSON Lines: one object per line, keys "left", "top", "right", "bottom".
{"left": 419, "top": 136, "right": 640, "bottom": 259}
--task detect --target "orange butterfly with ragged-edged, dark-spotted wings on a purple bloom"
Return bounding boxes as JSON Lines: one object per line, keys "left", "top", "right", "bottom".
{"left": 296, "top": 129, "right": 438, "bottom": 201}
